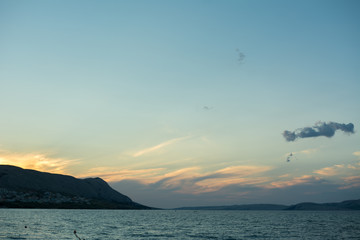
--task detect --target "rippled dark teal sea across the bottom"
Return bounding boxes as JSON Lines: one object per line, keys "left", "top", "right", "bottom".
{"left": 0, "top": 209, "right": 360, "bottom": 240}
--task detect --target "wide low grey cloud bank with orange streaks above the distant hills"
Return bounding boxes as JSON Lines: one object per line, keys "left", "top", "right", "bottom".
{"left": 109, "top": 164, "right": 360, "bottom": 208}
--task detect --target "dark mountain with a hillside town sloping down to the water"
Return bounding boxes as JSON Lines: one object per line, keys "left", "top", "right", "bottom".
{"left": 0, "top": 165, "right": 148, "bottom": 209}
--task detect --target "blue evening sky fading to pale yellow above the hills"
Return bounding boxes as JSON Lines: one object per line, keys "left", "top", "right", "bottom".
{"left": 0, "top": 0, "right": 360, "bottom": 208}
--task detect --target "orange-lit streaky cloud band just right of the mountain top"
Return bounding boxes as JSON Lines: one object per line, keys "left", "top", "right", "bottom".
{"left": 86, "top": 166, "right": 272, "bottom": 194}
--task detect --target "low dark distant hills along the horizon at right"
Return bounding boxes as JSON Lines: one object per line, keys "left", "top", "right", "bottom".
{"left": 176, "top": 199, "right": 360, "bottom": 211}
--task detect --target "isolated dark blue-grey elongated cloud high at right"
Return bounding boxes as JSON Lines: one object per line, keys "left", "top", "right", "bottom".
{"left": 283, "top": 122, "right": 354, "bottom": 142}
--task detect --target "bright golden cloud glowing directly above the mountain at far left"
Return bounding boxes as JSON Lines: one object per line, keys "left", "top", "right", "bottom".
{"left": 0, "top": 151, "right": 78, "bottom": 174}
